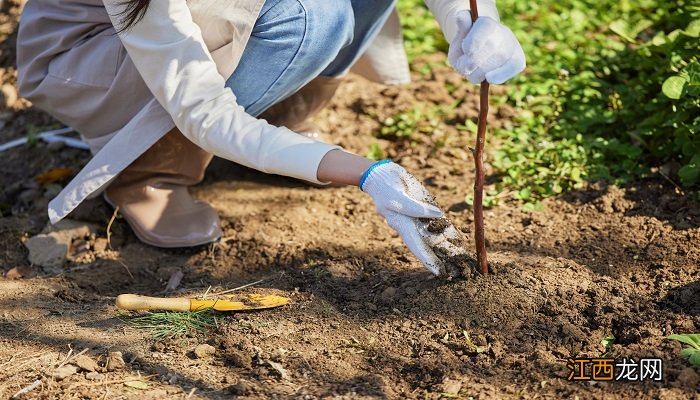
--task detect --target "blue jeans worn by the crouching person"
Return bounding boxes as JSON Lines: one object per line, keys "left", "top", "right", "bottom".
{"left": 226, "top": 0, "right": 395, "bottom": 116}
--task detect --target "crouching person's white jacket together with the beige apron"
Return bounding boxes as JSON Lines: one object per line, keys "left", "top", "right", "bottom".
{"left": 18, "top": 0, "right": 497, "bottom": 223}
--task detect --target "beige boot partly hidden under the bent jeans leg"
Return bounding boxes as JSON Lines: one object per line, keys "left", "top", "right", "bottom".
{"left": 260, "top": 76, "right": 343, "bottom": 143}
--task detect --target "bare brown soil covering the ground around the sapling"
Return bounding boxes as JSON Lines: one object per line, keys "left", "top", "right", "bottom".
{"left": 0, "top": 1, "right": 700, "bottom": 399}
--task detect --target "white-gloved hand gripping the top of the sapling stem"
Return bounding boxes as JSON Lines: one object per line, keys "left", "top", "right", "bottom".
{"left": 447, "top": 10, "right": 525, "bottom": 84}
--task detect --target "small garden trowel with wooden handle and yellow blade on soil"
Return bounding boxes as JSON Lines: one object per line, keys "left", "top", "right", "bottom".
{"left": 117, "top": 294, "right": 289, "bottom": 312}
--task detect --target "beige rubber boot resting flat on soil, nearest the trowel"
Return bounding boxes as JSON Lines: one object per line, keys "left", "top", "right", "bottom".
{"left": 104, "top": 129, "right": 221, "bottom": 248}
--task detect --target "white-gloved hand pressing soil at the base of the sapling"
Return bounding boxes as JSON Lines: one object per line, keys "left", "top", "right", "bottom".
{"left": 360, "top": 160, "right": 443, "bottom": 275}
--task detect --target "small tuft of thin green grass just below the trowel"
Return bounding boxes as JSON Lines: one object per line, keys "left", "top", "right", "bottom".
{"left": 119, "top": 309, "right": 219, "bottom": 341}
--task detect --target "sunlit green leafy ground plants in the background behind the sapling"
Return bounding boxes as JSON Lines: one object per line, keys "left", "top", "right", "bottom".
{"left": 396, "top": 0, "right": 700, "bottom": 208}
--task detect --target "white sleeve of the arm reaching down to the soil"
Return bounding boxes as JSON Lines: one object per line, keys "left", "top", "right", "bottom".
{"left": 103, "top": 0, "right": 339, "bottom": 183}
